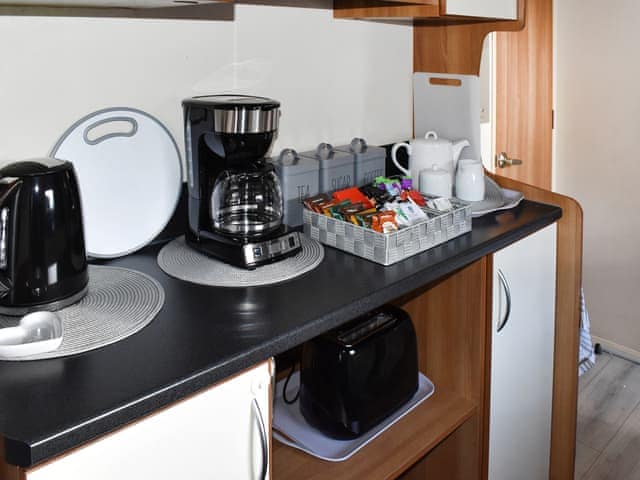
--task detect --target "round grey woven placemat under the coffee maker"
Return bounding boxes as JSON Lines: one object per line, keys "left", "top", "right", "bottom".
{"left": 158, "top": 235, "right": 324, "bottom": 287}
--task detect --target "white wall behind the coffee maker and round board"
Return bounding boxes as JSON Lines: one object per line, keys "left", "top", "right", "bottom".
{"left": 0, "top": 5, "right": 413, "bottom": 168}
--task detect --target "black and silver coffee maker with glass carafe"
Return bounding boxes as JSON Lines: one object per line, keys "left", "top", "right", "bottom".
{"left": 183, "top": 95, "right": 301, "bottom": 269}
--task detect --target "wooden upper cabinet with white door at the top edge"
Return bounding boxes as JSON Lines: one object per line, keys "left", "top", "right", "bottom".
{"left": 333, "top": 0, "right": 518, "bottom": 24}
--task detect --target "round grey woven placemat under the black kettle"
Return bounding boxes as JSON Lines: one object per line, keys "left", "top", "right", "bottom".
{"left": 0, "top": 265, "right": 164, "bottom": 361}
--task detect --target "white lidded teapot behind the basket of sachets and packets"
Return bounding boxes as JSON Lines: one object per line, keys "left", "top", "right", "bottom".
{"left": 391, "top": 132, "right": 471, "bottom": 180}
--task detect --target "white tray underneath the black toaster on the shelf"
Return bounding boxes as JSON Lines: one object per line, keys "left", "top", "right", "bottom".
{"left": 273, "top": 372, "right": 435, "bottom": 462}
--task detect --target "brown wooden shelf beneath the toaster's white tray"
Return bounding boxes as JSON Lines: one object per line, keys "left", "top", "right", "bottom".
{"left": 273, "top": 386, "right": 478, "bottom": 480}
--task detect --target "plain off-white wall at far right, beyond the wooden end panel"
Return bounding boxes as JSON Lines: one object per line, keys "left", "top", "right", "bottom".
{"left": 556, "top": 0, "right": 640, "bottom": 351}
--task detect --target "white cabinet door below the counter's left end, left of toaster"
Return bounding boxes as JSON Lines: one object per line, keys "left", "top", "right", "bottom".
{"left": 26, "top": 362, "right": 273, "bottom": 480}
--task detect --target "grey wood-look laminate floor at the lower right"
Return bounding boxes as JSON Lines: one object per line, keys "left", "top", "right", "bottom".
{"left": 575, "top": 353, "right": 640, "bottom": 480}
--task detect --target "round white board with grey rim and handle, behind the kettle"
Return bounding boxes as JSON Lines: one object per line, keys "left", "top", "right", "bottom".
{"left": 51, "top": 108, "right": 182, "bottom": 258}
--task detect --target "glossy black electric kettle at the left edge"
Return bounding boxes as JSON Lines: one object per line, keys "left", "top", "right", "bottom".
{"left": 0, "top": 158, "right": 89, "bottom": 315}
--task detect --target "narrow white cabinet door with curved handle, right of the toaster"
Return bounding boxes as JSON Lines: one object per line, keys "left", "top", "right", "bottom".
{"left": 489, "top": 224, "right": 556, "bottom": 480}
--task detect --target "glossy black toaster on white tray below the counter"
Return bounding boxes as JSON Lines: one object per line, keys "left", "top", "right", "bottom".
{"left": 300, "top": 305, "right": 418, "bottom": 440}
